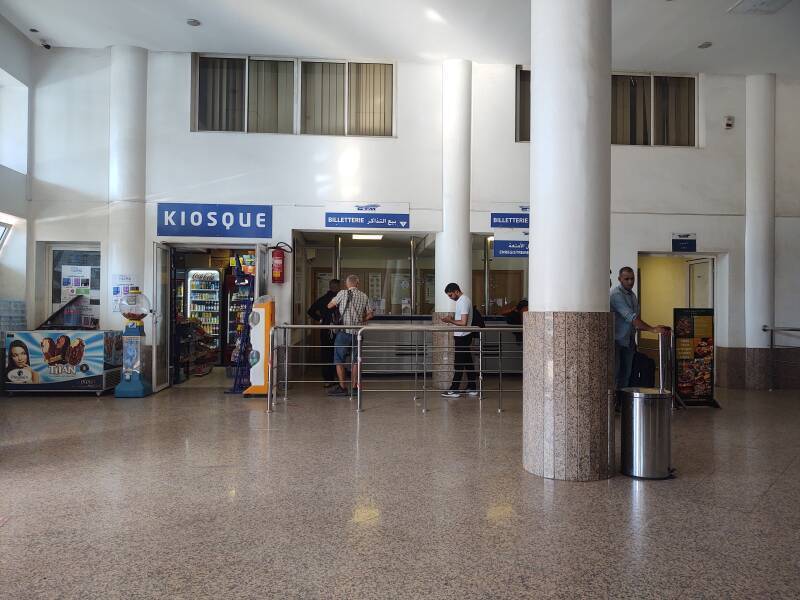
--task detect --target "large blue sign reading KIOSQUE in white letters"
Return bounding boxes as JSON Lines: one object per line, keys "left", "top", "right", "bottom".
{"left": 158, "top": 202, "right": 272, "bottom": 238}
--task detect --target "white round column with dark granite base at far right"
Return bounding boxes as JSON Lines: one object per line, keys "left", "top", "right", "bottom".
{"left": 744, "top": 74, "right": 775, "bottom": 389}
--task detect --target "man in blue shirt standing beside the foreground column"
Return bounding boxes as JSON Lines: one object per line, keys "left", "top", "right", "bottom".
{"left": 610, "top": 267, "right": 669, "bottom": 390}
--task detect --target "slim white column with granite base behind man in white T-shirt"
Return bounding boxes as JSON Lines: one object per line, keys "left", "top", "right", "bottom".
{"left": 433, "top": 60, "right": 475, "bottom": 388}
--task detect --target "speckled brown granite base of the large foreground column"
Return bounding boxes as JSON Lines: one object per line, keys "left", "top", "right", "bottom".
{"left": 522, "top": 312, "right": 614, "bottom": 481}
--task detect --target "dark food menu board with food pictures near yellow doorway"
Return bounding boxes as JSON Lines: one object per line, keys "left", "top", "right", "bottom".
{"left": 674, "top": 308, "right": 714, "bottom": 402}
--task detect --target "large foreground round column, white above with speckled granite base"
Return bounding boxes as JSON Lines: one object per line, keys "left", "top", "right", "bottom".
{"left": 523, "top": 0, "right": 613, "bottom": 481}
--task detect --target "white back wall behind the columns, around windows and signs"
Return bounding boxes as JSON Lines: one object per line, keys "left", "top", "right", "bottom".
{"left": 17, "top": 42, "right": 800, "bottom": 346}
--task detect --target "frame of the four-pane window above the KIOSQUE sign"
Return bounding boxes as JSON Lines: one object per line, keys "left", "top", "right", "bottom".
{"left": 189, "top": 52, "right": 398, "bottom": 139}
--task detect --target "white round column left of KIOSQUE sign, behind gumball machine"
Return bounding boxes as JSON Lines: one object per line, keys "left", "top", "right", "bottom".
{"left": 103, "top": 46, "right": 147, "bottom": 328}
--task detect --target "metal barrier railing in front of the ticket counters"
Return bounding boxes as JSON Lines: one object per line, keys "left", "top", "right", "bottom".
{"left": 267, "top": 324, "right": 522, "bottom": 413}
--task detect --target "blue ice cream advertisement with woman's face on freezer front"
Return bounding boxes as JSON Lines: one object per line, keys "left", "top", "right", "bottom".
{"left": 5, "top": 331, "right": 106, "bottom": 389}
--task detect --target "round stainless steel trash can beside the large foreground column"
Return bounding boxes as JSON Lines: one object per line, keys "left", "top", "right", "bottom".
{"left": 620, "top": 388, "right": 672, "bottom": 479}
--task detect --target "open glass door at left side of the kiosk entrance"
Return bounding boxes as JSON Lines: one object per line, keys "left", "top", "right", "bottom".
{"left": 150, "top": 242, "right": 170, "bottom": 392}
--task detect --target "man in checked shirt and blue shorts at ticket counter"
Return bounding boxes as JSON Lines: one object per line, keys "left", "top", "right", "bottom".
{"left": 328, "top": 275, "right": 373, "bottom": 396}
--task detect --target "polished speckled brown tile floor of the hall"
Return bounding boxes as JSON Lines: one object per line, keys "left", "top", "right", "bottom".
{"left": 0, "top": 387, "right": 800, "bottom": 599}
